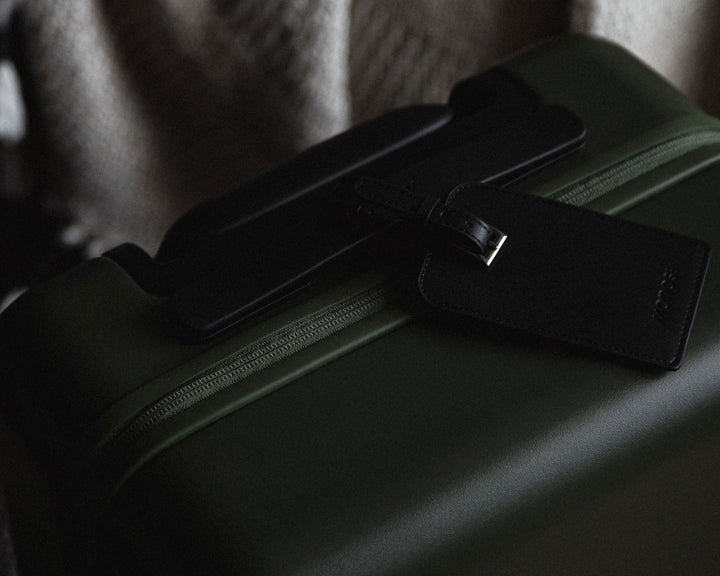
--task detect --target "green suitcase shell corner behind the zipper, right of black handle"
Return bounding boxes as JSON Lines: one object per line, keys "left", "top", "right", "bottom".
{"left": 504, "top": 36, "right": 720, "bottom": 205}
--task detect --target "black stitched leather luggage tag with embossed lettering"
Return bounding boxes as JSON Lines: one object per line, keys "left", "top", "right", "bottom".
{"left": 419, "top": 184, "right": 710, "bottom": 369}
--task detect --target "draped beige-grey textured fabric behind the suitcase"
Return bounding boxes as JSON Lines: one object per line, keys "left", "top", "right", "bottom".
{"left": 8, "top": 0, "right": 720, "bottom": 250}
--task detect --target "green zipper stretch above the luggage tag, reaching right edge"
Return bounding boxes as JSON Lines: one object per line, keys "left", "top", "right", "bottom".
{"left": 550, "top": 130, "right": 720, "bottom": 206}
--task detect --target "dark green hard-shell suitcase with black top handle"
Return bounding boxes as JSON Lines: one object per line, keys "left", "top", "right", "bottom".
{"left": 0, "top": 36, "right": 720, "bottom": 575}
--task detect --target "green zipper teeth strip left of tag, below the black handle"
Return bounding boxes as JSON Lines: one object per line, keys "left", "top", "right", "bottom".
{"left": 115, "top": 283, "right": 400, "bottom": 441}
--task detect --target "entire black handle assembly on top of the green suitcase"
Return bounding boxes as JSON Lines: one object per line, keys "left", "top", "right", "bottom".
{"left": 106, "top": 70, "right": 585, "bottom": 339}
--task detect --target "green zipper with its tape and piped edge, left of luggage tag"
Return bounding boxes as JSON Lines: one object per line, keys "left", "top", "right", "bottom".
{"left": 79, "top": 282, "right": 416, "bottom": 518}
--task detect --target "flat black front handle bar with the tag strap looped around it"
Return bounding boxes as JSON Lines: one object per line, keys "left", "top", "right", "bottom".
{"left": 155, "top": 107, "right": 584, "bottom": 339}
